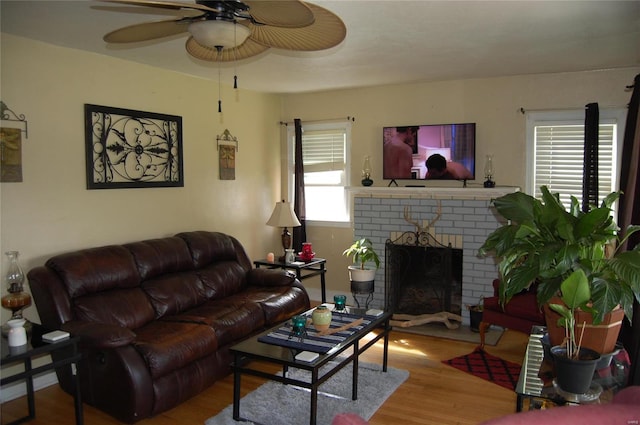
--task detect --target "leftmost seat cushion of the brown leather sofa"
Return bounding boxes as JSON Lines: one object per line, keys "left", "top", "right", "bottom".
{"left": 133, "top": 320, "right": 218, "bottom": 379}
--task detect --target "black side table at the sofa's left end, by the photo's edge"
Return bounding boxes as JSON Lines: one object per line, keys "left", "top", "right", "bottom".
{"left": 0, "top": 324, "right": 84, "bottom": 425}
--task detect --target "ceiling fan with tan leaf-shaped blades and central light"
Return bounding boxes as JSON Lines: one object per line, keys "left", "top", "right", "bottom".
{"left": 101, "top": 0, "right": 346, "bottom": 62}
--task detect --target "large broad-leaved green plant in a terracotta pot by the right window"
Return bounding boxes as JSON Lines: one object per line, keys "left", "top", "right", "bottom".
{"left": 480, "top": 186, "right": 640, "bottom": 354}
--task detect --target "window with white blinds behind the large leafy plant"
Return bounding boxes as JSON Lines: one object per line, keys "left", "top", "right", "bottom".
{"left": 526, "top": 109, "right": 626, "bottom": 206}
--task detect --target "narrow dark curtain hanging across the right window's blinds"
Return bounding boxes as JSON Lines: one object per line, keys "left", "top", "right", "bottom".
{"left": 582, "top": 103, "right": 600, "bottom": 212}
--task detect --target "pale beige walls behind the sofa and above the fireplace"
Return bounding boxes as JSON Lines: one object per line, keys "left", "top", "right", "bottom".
{"left": 0, "top": 34, "right": 640, "bottom": 322}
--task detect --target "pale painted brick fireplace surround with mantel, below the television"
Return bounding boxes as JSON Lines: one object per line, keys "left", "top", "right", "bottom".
{"left": 351, "top": 187, "right": 518, "bottom": 323}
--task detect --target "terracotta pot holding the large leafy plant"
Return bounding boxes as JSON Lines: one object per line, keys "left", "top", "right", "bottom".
{"left": 543, "top": 298, "right": 624, "bottom": 354}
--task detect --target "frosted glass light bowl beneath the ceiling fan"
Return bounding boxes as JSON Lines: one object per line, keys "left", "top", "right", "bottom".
{"left": 189, "top": 20, "right": 251, "bottom": 49}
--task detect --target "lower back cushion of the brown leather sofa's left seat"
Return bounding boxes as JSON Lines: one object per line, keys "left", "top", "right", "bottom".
{"left": 72, "top": 288, "right": 155, "bottom": 329}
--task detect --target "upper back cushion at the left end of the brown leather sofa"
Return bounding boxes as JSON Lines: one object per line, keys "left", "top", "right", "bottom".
{"left": 46, "top": 245, "right": 140, "bottom": 298}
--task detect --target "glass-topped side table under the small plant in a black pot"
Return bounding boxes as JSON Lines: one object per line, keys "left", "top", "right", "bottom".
{"left": 515, "top": 326, "right": 629, "bottom": 412}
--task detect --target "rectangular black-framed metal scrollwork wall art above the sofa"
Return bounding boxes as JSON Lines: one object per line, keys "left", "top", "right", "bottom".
{"left": 84, "top": 104, "right": 184, "bottom": 189}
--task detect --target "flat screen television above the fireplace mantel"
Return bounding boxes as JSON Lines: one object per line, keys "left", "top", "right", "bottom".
{"left": 382, "top": 123, "right": 476, "bottom": 181}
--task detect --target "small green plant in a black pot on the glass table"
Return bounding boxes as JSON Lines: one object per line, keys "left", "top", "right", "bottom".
{"left": 549, "top": 269, "right": 600, "bottom": 394}
